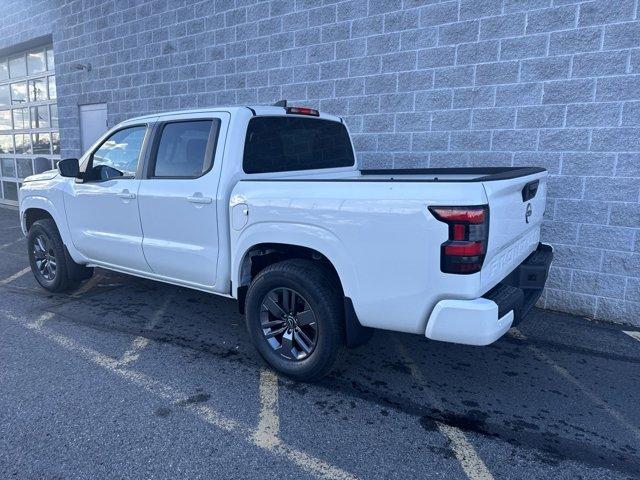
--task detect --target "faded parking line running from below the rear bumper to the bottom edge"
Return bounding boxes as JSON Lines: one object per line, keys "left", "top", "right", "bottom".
{"left": 394, "top": 339, "right": 493, "bottom": 480}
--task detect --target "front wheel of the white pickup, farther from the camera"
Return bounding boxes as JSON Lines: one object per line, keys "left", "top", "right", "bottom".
{"left": 27, "top": 218, "right": 93, "bottom": 293}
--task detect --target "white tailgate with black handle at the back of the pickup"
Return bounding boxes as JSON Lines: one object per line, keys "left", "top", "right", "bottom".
{"left": 480, "top": 172, "right": 547, "bottom": 290}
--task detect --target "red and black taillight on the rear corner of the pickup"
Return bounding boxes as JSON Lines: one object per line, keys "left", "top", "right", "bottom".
{"left": 429, "top": 205, "right": 489, "bottom": 274}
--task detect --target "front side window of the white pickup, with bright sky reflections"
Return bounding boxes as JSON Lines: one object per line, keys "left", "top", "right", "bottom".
{"left": 88, "top": 126, "right": 147, "bottom": 180}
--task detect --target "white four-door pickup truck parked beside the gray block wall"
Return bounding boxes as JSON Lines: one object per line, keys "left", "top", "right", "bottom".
{"left": 20, "top": 102, "right": 552, "bottom": 380}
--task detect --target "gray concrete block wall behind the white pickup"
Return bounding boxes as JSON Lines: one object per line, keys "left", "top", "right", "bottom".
{"left": 0, "top": 0, "right": 640, "bottom": 325}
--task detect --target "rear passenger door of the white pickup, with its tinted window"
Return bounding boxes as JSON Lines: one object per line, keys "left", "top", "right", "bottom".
{"left": 139, "top": 113, "right": 229, "bottom": 287}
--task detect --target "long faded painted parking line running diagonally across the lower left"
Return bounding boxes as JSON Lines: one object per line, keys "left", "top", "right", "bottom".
{"left": 10, "top": 311, "right": 357, "bottom": 480}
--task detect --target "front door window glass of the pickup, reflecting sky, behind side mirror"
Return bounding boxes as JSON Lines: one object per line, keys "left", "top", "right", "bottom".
{"left": 92, "top": 127, "right": 147, "bottom": 176}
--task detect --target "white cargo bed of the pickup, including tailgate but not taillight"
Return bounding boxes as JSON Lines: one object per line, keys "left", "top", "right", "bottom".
{"left": 230, "top": 167, "right": 547, "bottom": 333}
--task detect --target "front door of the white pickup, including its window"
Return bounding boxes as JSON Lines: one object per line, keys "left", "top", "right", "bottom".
{"left": 64, "top": 124, "right": 149, "bottom": 272}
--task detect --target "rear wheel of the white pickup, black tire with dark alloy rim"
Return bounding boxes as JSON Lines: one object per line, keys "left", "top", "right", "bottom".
{"left": 245, "top": 259, "right": 345, "bottom": 381}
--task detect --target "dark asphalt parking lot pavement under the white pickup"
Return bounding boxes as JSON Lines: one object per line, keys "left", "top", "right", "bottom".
{"left": 0, "top": 207, "right": 640, "bottom": 480}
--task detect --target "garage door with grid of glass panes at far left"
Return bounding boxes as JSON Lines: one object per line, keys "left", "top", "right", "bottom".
{"left": 0, "top": 45, "right": 60, "bottom": 205}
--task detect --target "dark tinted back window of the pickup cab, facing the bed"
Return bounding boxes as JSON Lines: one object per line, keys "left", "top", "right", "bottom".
{"left": 242, "top": 117, "right": 354, "bottom": 173}
